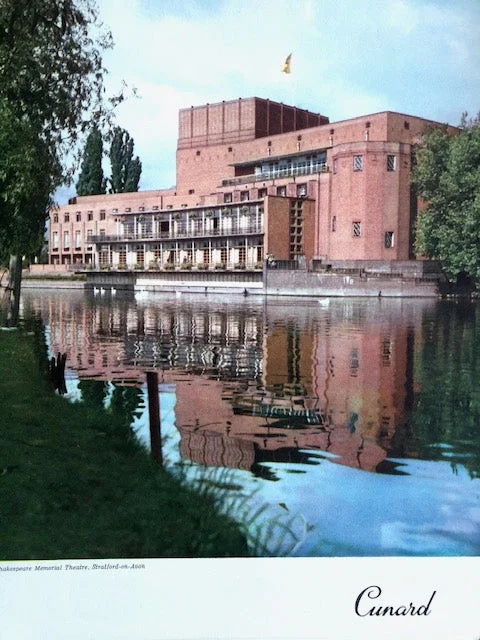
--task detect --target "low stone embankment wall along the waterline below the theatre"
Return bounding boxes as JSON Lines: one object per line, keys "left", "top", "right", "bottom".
{"left": 23, "top": 260, "right": 442, "bottom": 298}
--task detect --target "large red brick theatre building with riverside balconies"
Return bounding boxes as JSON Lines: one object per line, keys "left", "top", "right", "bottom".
{"left": 49, "top": 98, "right": 453, "bottom": 270}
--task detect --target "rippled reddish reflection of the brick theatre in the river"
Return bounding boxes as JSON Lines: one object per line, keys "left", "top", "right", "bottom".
{"left": 24, "top": 295, "right": 422, "bottom": 480}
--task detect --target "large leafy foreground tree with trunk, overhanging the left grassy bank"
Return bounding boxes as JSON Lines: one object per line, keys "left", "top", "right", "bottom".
{"left": 0, "top": 0, "right": 111, "bottom": 324}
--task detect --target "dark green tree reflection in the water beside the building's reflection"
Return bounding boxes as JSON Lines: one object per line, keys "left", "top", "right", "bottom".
{"left": 414, "top": 302, "right": 480, "bottom": 477}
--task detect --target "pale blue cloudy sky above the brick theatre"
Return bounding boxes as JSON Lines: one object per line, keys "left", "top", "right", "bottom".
{"left": 64, "top": 0, "right": 480, "bottom": 196}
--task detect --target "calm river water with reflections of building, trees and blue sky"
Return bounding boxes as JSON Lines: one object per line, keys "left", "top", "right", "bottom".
{"left": 23, "top": 290, "right": 480, "bottom": 556}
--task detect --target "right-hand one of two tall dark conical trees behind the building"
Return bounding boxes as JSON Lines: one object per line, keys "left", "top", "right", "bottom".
{"left": 110, "top": 127, "right": 142, "bottom": 193}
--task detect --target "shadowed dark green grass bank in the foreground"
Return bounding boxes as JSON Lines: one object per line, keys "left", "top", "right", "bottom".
{"left": 0, "top": 331, "right": 248, "bottom": 560}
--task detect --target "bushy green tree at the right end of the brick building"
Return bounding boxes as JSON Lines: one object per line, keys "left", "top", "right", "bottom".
{"left": 413, "top": 114, "right": 480, "bottom": 282}
